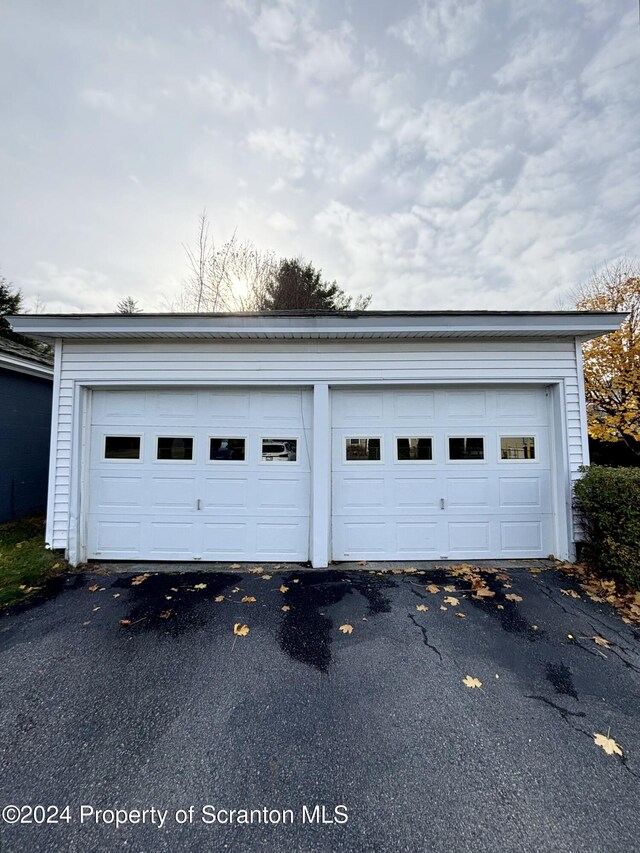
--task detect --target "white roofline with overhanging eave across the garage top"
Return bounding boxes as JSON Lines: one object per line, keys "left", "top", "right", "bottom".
{"left": 7, "top": 311, "right": 628, "bottom": 341}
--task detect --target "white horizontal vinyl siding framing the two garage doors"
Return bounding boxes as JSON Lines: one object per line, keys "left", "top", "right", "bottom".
{"left": 49, "top": 338, "right": 583, "bottom": 548}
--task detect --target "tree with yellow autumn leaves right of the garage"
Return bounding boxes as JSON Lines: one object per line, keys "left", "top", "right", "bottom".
{"left": 576, "top": 259, "right": 640, "bottom": 457}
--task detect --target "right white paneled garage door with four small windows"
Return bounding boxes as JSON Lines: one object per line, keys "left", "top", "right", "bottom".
{"left": 332, "top": 387, "right": 554, "bottom": 560}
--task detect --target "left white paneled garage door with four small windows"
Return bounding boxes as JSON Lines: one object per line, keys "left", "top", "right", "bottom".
{"left": 87, "top": 389, "right": 311, "bottom": 561}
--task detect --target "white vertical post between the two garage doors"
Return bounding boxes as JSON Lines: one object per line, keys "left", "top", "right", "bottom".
{"left": 311, "top": 382, "right": 331, "bottom": 569}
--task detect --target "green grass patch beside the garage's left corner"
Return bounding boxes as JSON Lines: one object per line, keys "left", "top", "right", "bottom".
{"left": 0, "top": 518, "right": 69, "bottom": 607}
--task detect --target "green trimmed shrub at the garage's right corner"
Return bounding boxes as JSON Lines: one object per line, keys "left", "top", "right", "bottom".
{"left": 575, "top": 465, "right": 640, "bottom": 589}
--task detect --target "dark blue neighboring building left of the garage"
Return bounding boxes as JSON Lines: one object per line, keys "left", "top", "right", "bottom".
{"left": 0, "top": 338, "right": 53, "bottom": 522}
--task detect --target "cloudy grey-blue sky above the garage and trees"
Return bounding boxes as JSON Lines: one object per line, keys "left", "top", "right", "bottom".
{"left": 0, "top": 0, "right": 640, "bottom": 312}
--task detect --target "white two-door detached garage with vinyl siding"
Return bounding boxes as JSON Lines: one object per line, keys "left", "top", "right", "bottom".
{"left": 11, "top": 311, "right": 625, "bottom": 568}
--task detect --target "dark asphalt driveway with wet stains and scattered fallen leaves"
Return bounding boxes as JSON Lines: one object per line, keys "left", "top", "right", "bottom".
{"left": 0, "top": 567, "right": 640, "bottom": 853}
